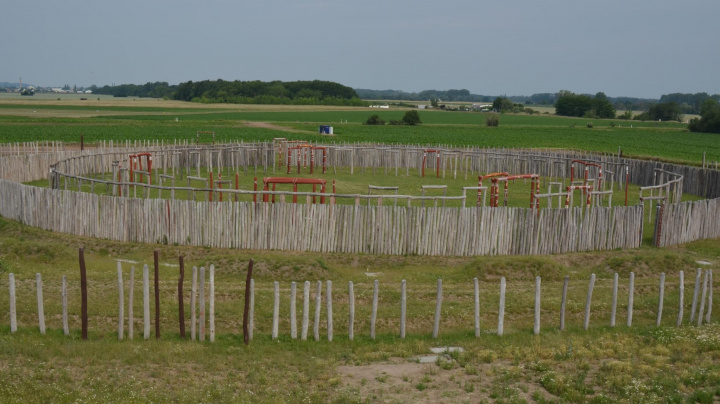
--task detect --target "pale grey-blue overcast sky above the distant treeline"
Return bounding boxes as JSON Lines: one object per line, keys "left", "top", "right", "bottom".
{"left": 0, "top": 0, "right": 720, "bottom": 98}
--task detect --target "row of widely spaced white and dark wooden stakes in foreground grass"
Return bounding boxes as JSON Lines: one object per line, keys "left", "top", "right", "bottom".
{"left": 4, "top": 249, "right": 713, "bottom": 342}
